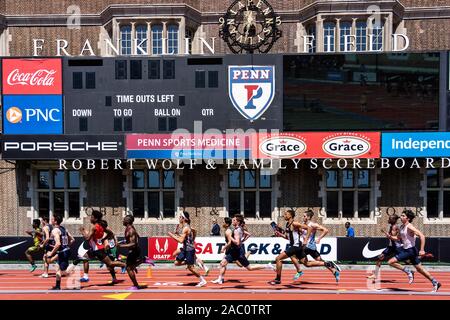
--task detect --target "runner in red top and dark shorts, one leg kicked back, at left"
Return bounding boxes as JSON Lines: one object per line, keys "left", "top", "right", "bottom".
{"left": 80, "top": 210, "right": 126, "bottom": 285}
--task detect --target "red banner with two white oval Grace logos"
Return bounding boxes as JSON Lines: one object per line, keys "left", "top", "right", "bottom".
{"left": 252, "top": 132, "right": 380, "bottom": 159}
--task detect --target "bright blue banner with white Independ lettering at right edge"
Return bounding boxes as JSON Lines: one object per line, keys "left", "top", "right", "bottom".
{"left": 381, "top": 132, "right": 450, "bottom": 158}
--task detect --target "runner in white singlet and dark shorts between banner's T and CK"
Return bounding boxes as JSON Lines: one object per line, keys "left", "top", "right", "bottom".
{"left": 212, "top": 214, "right": 274, "bottom": 284}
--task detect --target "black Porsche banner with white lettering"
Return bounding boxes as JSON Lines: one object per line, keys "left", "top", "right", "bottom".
{"left": 0, "top": 135, "right": 125, "bottom": 160}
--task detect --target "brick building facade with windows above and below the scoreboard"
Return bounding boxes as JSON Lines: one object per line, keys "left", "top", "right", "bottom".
{"left": 0, "top": 0, "right": 450, "bottom": 236}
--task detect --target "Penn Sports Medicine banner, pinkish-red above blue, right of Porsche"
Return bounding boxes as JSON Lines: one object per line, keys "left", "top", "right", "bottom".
{"left": 126, "top": 134, "right": 250, "bottom": 159}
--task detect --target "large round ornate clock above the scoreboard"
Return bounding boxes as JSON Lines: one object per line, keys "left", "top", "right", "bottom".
{"left": 219, "top": 0, "right": 281, "bottom": 53}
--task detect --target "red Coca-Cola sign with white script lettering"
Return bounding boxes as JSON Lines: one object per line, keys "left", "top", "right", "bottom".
{"left": 2, "top": 58, "right": 62, "bottom": 95}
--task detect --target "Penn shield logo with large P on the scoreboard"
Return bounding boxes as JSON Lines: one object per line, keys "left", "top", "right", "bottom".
{"left": 228, "top": 66, "right": 275, "bottom": 120}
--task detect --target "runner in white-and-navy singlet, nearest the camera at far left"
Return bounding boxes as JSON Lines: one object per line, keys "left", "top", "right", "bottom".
{"left": 47, "top": 216, "right": 75, "bottom": 290}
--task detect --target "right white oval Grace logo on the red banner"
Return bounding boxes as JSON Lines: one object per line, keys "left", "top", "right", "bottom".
{"left": 322, "top": 136, "right": 371, "bottom": 158}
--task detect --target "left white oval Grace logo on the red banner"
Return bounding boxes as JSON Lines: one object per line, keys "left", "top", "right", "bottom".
{"left": 259, "top": 137, "right": 306, "bottom": 158}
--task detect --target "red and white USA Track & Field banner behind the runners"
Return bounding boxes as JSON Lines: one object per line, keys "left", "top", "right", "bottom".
{"left": 148, "top": 237, "right": 337, "bottom": 261}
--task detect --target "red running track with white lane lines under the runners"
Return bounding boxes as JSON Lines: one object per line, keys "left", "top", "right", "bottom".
{"left": 0, "top": 267, "right": 450, "bottom": 300}
